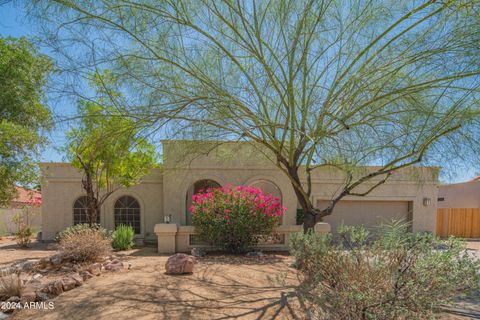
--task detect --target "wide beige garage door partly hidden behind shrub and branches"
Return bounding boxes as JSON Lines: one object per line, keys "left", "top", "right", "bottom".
{"left": 317, "top": 200, "right": 409, "bottom": 232}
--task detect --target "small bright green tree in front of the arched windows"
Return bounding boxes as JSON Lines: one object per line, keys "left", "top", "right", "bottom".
{"left": 66, "top": 77, "right": 157, "bottom": 224}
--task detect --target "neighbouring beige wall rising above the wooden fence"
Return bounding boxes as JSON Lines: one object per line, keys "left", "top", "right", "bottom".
{"left": 438, "top": 180, "right": 480, "bottom": 208}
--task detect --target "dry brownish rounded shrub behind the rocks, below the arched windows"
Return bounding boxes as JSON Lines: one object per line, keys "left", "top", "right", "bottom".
{"left": 58, "top": 226, "right": 111, "bottom": 262}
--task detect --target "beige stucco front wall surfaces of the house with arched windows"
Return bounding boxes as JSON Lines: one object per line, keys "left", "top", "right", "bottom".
{"left": 41, "top": 141, "right": 438, "bottom": 240}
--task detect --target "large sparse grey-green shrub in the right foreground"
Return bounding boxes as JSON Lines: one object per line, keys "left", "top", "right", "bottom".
{"left": 291, "top": 223, "right": 480, "bottom": 319}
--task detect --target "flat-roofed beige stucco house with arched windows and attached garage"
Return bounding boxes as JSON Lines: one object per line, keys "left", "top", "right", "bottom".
{"left": 41, "top": 141, "right": 438, "bottom": 248}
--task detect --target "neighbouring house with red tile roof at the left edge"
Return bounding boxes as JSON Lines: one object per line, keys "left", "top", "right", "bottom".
{"left": 0, "top": 187, "right": 42, "bottom": 235}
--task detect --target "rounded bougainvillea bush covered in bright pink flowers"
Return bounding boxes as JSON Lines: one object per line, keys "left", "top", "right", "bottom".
{"left": 189, "top": 185, "right": 285, "bottom": 253}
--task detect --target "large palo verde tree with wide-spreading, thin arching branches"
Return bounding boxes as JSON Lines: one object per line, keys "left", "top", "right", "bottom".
{"left": 32, "top": 0, "right": 480, "bottom": 230}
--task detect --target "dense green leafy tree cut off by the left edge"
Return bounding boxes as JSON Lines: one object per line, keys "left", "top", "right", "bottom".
{"left": 0, "top": 37, "right": 52, "bottom": 207}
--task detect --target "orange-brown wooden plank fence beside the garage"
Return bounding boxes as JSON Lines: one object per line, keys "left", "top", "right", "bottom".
{"left": 437, "top": 208, "right": 480, "bottom": 238}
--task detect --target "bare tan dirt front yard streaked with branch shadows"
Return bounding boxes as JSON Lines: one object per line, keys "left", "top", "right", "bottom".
{"left": 0, "top": 241, "right": 480, "bottom": 320}
